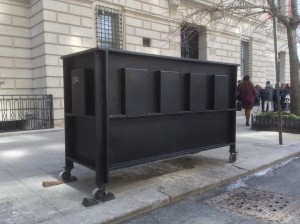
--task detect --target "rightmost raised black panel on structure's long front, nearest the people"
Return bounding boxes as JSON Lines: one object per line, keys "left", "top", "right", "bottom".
{"left": 214, "top": 75, "right": 228, "bottom": 110}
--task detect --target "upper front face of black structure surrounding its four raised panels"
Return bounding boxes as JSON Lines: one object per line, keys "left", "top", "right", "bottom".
{"left": 108, "top": 50, "right": 237, "bottom": 116}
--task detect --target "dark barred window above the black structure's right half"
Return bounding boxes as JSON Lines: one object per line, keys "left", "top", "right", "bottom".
{"left": 181, "top": 26, "right": 199, "bottom": 59}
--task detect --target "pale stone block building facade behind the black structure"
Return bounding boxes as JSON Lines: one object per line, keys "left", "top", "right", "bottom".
{"left": 0, "top": 0, "right": 289, "bottom": 126}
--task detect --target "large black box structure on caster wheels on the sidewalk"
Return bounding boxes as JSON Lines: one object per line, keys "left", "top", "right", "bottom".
{"left": 61, "top": 48, "right": 237, "bottom": 200}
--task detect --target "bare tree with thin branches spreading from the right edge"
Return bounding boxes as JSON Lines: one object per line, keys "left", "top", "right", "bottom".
{"left": 177, "top": 0, "right": 300, "bottom": 116}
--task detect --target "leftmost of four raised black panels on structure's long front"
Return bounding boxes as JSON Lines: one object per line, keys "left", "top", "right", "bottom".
{"left": 122, "top": 68, "right": 148, "bottom": 116}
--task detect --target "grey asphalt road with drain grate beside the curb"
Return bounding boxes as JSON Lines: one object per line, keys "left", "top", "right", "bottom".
{"left": 123, "top": 158, "right": 300, "bottom": 224}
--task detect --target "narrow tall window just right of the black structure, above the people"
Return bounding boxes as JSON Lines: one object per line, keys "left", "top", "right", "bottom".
{"left": 241, "top": 40, "right": 252, "bottom": 77}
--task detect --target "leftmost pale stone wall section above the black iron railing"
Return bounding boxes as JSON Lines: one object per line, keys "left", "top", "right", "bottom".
{"left": 0, "top": 0, "right": 33, "bottom": 95}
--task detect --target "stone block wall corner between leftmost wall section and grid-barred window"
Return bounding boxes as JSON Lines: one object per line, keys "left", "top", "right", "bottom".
{"left": 31, "top": 0, "right": 96, "bottom": 126}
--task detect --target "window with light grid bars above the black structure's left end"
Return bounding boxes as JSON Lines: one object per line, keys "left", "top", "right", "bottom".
{"left": 96, "top": 6, "right": 123, "bottom": 49}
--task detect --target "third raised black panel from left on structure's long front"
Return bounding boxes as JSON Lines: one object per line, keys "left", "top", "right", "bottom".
{"left": 188, "top": 73, "right": 208, "bottom": 112}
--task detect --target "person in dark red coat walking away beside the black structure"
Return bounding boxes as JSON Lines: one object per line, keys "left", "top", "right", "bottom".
{"left": 239, "top": 75, "right": 255, "bottom": 126}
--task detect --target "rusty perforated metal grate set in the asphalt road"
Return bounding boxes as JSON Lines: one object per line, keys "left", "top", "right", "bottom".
{"left": 205, "top": 187, "right": 300, "bottom": 221}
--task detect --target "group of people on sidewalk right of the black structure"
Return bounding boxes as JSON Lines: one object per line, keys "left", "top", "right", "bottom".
{"left": 237, "top": 75, "right": 291, "bottom": 126}
